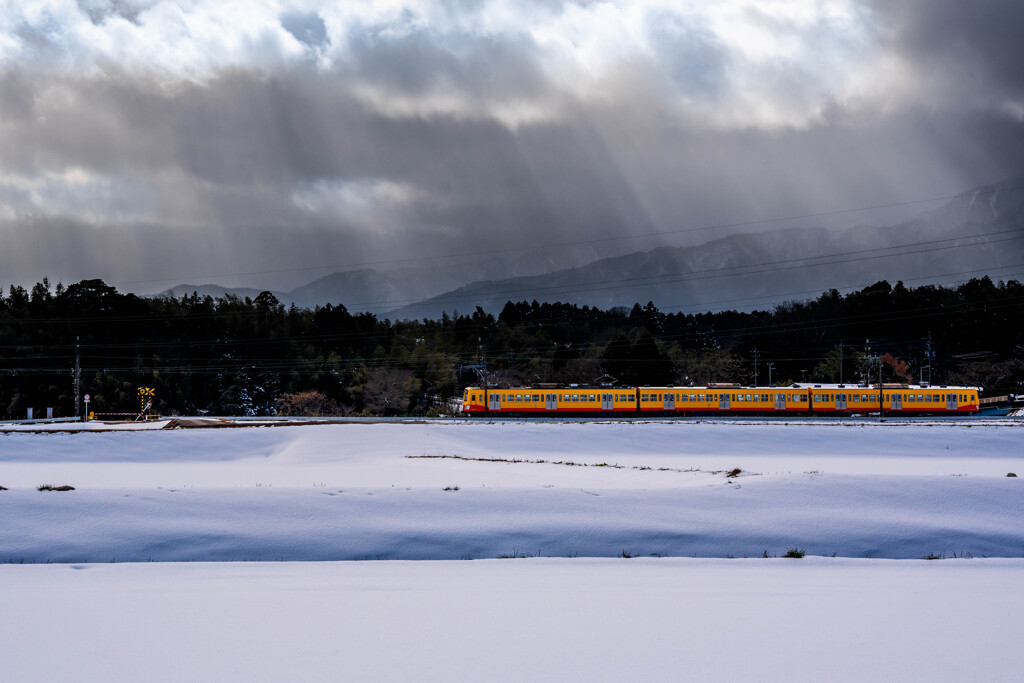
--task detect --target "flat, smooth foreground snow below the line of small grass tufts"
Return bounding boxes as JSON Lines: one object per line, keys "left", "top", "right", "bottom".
{"left": 0, "top": 558, "right": 1024, "bottom": 681}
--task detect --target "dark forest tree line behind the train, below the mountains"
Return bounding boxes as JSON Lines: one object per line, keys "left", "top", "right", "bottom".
{"left": 0, "top": 278, "right": 1024, "bottom": 419}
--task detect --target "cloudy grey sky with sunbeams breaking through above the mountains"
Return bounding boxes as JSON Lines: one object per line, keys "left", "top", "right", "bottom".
{"left": 0, "top": 0, "right": 1024, "bottom": 291}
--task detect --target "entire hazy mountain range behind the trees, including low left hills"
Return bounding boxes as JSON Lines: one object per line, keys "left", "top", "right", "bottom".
{"left": 151, "top": 181, "right": 1024, "bottom": 319}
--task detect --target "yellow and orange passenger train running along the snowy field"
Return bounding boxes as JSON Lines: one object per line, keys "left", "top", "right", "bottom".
{"left": 462, "top": 384, "right": 979, "bottom": 417}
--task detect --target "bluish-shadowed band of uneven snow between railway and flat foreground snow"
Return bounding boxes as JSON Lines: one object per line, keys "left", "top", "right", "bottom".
{"left": 0, "top": 422, "right": 1024, "bottom": 562}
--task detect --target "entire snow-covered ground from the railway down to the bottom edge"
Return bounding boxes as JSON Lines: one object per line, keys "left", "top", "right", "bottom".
{"left": 0, "top": 421, "right": 1024, "bottom": 680}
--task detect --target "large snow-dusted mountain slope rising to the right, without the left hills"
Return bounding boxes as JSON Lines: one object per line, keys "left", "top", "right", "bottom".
{"left": 393, "top": 182, "right": 1024, "bottom": 317}
